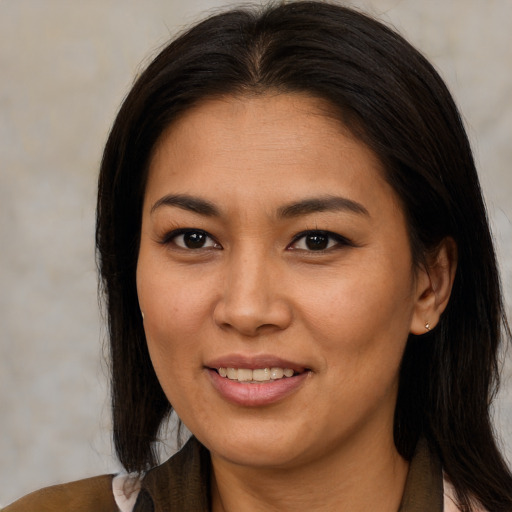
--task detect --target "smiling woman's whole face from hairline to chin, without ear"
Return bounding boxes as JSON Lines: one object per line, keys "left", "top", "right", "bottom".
{"left": 137, "top": 94, "right": 428, "bottom": 467}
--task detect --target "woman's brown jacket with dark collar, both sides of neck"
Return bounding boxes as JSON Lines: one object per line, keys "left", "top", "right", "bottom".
{"left": 2, "top": 438, "right": 443, "bottom": 512}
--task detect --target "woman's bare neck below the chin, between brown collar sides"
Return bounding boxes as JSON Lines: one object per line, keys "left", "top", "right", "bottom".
{"left": 212, "top": 432, "right": 408, "bottom": 512}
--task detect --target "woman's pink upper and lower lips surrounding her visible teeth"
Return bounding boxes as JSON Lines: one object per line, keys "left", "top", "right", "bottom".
{"left": 205, "top": 355, "right": 311, "bottom": 407}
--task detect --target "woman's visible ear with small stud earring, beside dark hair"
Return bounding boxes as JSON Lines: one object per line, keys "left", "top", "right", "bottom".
{"left": 411, "top": 237, "right": 457, "bottom": 335}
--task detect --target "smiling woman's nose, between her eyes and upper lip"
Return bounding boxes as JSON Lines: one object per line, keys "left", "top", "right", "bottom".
{"left": 214, "top": 254, "right": 292, "bottom": 337}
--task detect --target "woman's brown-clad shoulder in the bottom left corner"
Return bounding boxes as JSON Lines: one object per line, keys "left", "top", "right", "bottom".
{"left": 1, "top": 475, "right": 118, "bottom": 512}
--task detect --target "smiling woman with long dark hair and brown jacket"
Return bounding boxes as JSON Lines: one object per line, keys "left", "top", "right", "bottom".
{"left": 7, "top": 2, "right": 512, "bottom": 512}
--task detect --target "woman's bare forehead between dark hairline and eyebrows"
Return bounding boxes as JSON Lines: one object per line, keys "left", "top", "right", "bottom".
{"left": 146, "top": 94, "right": 400, "bottom": 217}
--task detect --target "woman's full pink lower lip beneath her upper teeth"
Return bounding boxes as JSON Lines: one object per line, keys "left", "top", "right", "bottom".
{"left": 207, "top": 368, "right": 310, "bottom": 407}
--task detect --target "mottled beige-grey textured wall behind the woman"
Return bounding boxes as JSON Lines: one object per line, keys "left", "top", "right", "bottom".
{"left": 0, "top": 0, "right": 512, "bottom": 504}
